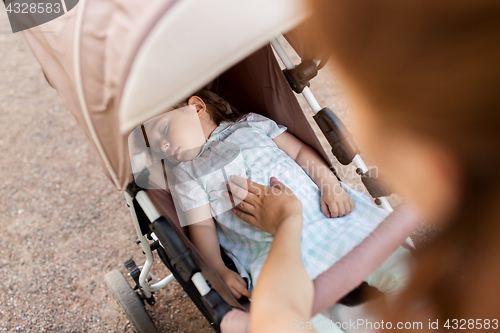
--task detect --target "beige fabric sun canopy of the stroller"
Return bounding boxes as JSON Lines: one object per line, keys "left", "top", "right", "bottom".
{"left": 23, "top": 0, "right": 307, "bottom": 190}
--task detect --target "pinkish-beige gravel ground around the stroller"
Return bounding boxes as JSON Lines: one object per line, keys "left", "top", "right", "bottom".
{"left": 0, "top": 5, "right": 432, "bottom": 332}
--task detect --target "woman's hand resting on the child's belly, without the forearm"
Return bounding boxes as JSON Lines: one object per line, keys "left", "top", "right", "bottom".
{"left": 225, "top": 175, "right": 302, "bottom": 235}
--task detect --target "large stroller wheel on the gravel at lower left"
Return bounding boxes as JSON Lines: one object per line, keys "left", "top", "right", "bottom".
{"left": 104, "top": 269, "right": 157, "bottom": 333}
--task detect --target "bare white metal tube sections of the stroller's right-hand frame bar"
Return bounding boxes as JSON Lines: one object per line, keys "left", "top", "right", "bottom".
{"left": 271, "top": 38, "right": 415, "bottom": 248}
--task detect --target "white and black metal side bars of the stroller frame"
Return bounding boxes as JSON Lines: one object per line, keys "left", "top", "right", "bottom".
{"left": 112, "top": 38, "right": 414, "bottom": 332}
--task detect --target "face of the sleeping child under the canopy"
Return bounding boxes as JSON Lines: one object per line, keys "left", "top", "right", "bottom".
{"left": 144, "top": 105, "right": 206, "bottom": 164}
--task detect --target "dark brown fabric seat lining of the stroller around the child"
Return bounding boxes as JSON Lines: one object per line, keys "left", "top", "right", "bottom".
{"left": 128, "top": 45, "right": 336, "bottom": 309}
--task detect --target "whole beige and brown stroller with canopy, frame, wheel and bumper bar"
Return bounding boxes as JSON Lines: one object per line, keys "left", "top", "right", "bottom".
{"left": 24, "top": 0, "right": 419, "bottom": 333}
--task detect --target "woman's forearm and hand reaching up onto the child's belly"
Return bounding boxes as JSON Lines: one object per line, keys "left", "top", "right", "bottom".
{"left": 227, "top": 176, "right": 314, "bottom": 333}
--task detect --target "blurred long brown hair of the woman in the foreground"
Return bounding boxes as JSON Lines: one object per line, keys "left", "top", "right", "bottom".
{"left": 312, "top": 0, "right": 500, "bottom": 328}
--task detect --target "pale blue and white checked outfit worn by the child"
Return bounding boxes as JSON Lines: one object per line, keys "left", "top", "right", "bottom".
{"left": 171, "top": 113, "right": 389, "bottom": 289}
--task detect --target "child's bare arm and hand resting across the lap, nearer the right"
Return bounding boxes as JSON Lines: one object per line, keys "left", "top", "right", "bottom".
{"left": 273, "top": 132, "right": 354, "bottom": 217}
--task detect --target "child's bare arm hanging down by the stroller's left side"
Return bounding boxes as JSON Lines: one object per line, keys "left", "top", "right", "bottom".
{"left": 186, "top": 206, "right": 251, "bottom": 299}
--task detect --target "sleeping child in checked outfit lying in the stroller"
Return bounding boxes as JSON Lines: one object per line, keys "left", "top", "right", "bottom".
{"left": 144, "top": 89, "right": 407, "bottom": 299}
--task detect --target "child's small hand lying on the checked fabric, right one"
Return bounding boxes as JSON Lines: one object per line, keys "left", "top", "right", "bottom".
{"left": 320, "top": 182, "right": 354, "bottom": 218}
